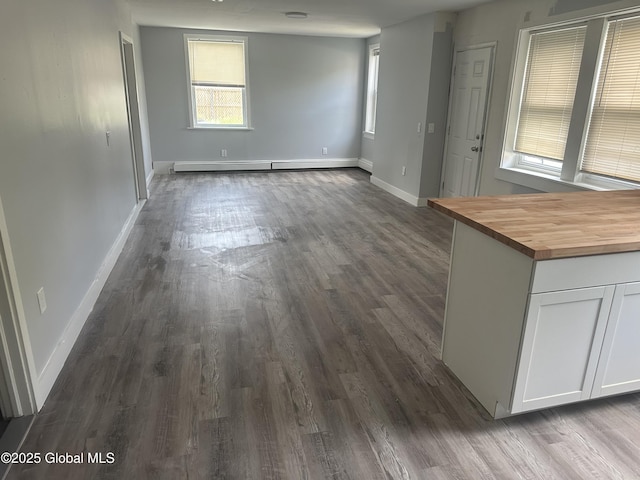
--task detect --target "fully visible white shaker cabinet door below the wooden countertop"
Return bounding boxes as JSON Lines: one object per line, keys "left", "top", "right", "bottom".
{"left": 511, "top": 286, "right": 615, "bottom": 413}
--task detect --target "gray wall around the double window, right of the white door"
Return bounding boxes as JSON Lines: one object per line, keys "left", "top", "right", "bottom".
{"left": 455, "top": 0, "right": 638, "bottom": 195}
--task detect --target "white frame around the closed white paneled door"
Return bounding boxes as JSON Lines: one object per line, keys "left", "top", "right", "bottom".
{"left": 439, "top": 42, "right": 498, "bottom": 197}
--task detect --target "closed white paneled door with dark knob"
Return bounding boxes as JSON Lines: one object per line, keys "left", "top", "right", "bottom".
{"left": 440, "top": 47, "right": 493, "bottom": 197}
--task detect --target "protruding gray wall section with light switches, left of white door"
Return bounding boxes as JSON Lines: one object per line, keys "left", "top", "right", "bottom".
{"left": 371, "top": 13, "right": 455, "bottom": 197}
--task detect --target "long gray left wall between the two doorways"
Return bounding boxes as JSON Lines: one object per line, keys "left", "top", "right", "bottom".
{"left": 0, "top": 0, "right": 145, "bottom": 375}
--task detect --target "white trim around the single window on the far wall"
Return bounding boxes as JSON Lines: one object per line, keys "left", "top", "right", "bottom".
{"left": 184, "top": 33, "right": 253, "bottom": 131}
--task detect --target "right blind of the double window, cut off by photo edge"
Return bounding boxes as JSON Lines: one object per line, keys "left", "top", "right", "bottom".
{"left": 582, "top": 17, "right": 640, "bottom": 181}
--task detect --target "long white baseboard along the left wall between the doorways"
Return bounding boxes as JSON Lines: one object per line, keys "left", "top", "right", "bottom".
{"left": 34, "top": 200, "right": 145, "bottom": 410}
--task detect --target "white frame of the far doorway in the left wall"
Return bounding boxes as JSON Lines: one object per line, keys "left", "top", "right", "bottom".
{"left": 120, "top": 32, "right": 149, "bottom": 202}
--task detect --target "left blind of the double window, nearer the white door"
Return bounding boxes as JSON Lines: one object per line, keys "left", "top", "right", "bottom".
{"left": 514, "top": 26, "right": 586, "bottom": 161}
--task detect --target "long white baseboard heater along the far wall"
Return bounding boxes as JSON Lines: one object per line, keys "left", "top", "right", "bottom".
{"left": 153, "top": 158, "right": 359, "bottom": 175}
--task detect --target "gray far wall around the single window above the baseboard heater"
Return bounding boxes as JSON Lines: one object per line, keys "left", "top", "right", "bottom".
{"left": 140, "top": 27, "right": 365, "bottom": 167}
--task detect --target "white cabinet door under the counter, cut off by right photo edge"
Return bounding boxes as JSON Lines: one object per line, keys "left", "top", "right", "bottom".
{"left": 591, "top": 283, "right": 640, "bottom": 397}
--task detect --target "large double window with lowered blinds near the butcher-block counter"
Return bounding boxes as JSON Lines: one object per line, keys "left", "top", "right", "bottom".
{"left": 498, "top": 13, "right": 640, "bottom": 189}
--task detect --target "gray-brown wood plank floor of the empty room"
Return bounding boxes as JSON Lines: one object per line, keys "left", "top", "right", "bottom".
{"left": 8, "top": 170, "right": 640, "bottom": 480}
